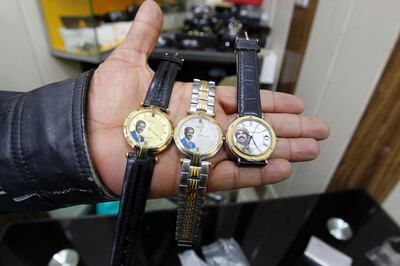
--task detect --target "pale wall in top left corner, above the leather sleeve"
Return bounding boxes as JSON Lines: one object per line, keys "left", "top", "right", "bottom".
{"left": 0, "top": 0, "right": 81, "bottom": 91}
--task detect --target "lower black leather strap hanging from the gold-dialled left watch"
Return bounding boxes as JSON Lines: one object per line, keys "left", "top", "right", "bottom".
{"left": 111, "top": 153, "right": 155, "bottom": 266}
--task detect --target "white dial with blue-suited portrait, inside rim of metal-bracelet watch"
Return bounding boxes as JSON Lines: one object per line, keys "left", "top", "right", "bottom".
{"left": 178, "top": 117, "right": 221, "bottom": 154}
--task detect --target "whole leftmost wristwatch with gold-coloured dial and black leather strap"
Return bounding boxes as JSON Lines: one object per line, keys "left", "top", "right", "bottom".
{"left": 111, "top": 54, "right": 183, "bottom": 266}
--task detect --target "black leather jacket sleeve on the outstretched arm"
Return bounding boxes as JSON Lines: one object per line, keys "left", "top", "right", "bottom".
{"left": 0, "top": 71, "right": 117, "bottom": 212}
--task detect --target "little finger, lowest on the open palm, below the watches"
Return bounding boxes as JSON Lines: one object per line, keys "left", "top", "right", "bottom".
{"left": 207, "top": 159, "right": 292, "bottom": 191}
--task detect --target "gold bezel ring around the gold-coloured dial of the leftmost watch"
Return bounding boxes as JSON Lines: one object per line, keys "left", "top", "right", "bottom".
{"left": 123, "top": 106, "right": 174, "bottom": 154}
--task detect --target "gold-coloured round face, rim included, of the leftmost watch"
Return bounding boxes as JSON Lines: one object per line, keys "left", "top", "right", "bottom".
{"left": 124, "top": 108, "right": 172, "bottom": 151}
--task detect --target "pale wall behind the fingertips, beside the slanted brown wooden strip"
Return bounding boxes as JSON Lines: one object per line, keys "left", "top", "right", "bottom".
{"left": 273, "top": 0, "right": 400, "bottom": 222}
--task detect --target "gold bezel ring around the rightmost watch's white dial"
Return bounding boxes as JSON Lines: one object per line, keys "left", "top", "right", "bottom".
{"left": 226, "top": 115, "right": 276, "bottom": 162}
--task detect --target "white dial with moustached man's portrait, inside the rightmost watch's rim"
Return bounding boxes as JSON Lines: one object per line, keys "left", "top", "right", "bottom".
{"left": 233, "top": 120, "right": 272, "bottom": 156}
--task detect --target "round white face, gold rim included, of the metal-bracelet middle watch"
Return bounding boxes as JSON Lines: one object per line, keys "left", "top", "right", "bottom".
{"left": 174, "top": 115, "right": 222, "bottom": 157}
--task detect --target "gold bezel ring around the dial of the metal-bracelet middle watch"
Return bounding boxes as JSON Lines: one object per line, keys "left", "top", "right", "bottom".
{"left": 174, "top": 113, "right": 223, "bottom": 160}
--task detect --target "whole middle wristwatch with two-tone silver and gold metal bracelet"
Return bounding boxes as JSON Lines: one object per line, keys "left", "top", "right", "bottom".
{"left": 174, "top": 79, "right": 223, "bottom": 247}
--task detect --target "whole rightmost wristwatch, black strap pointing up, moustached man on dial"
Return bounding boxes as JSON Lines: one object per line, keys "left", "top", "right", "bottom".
{"left": 226, "top": 34, "right": 276, "bottom": 166}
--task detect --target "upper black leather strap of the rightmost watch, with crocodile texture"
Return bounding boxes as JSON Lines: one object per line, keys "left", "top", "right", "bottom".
{"left": 235, "top": 38, "right": 262, "bottom": 117}
